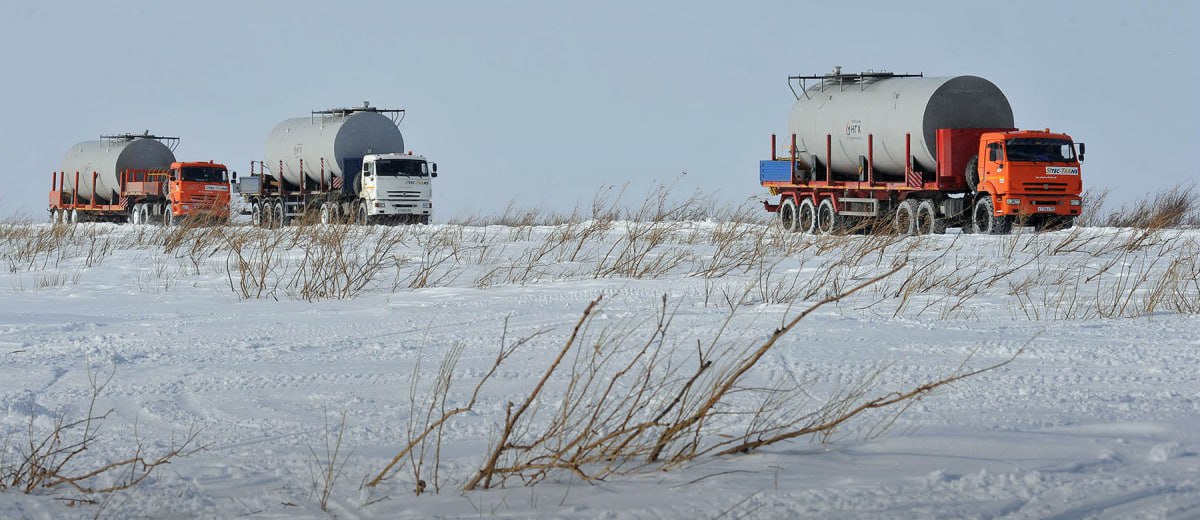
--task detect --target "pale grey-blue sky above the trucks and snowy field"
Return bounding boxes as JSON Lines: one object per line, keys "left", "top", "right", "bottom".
{"left": 0, "top": 0, "right": 1200, "bottom": 221}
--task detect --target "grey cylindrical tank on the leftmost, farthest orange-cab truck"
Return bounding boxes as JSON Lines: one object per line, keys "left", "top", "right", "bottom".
{"left": 62, "top": 132, "right": 179, "bottom": 203}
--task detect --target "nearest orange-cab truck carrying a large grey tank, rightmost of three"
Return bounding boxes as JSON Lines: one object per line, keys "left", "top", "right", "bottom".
{"left": 758, "top": 67, "right": 1085, "bottom": 234}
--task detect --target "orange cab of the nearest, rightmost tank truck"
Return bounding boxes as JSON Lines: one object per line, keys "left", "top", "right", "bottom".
{"left": 966, "top": 128, "right": 1084, "bottom": 227}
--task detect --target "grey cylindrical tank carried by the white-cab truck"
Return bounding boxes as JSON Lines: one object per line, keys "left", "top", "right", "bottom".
{"left": 265, "top": 103, "right": 404, "bottom": 186}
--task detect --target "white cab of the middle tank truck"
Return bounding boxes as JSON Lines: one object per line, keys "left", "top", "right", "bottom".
{"left": 359, "top": 153, "right": 438, "bottom": 223}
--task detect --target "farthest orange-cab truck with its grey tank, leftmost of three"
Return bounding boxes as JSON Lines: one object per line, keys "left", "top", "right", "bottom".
{"left": 49, "top": 132, "right": 229, "bottom": 226}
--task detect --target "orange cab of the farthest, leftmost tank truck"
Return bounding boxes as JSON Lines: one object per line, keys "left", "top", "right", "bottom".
{"left": 167, "top": 161, "right": 229, "bottom": 219}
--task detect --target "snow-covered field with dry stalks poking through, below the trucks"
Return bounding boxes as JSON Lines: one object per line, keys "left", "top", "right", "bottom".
{"left": 0, "top": 220, "right": 1200, "bottom": 519}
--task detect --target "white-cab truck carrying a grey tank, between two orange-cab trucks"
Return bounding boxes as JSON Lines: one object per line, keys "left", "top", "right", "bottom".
{"left": 238, "top": 103, "right": 437, "bottom": 227}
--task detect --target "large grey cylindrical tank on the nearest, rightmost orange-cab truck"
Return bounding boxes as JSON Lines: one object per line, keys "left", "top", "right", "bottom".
{"left": 788, "top": 72, "right": 1013, "bottom": 180}
